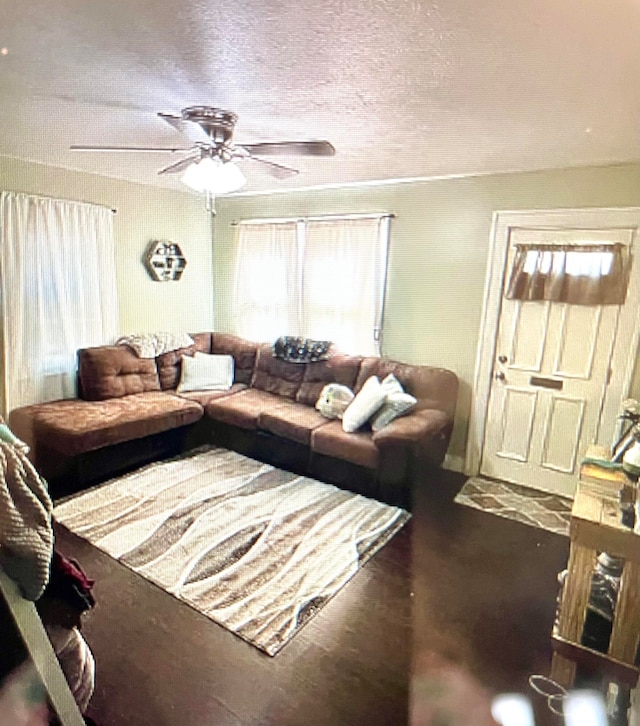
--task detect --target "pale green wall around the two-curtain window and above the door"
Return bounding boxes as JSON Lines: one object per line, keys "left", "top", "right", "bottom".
{"left": 214, "top": 164, "right": 640, "bottom": 464}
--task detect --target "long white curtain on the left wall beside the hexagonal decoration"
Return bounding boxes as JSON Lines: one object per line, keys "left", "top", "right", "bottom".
{"left": 0, "top": 192, "right": 118, "bottom": 414}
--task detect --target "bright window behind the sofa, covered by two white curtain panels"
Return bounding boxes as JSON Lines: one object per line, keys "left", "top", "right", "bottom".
{"left": 234, "top": 215, "right": 389, "bottom": 355}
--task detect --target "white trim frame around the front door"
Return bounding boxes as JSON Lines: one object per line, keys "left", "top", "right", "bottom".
{"left": 464, "top": 207, "right": 640, "bottom": 476}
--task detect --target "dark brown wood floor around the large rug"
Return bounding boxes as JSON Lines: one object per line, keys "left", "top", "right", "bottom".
{"left": 2, "top": 472, "right": 568, "bottom": 726}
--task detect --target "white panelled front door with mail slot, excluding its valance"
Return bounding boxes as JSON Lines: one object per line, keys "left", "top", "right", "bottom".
{"left": 481, "top": 229, "right": 637, "bottom": 496}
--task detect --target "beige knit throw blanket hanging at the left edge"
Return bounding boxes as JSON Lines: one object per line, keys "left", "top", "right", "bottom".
{"left": 0, "top": 441, "right": 53, "bottom": 600}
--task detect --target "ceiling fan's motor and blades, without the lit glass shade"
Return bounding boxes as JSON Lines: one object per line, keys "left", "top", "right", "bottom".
{"left": 71, "top": 106, "right": 335, "bottom": 179}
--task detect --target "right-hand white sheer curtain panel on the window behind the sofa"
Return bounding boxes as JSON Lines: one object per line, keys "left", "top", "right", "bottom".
{"left": 302, "top": 217, "right": 389, "bottom": 355}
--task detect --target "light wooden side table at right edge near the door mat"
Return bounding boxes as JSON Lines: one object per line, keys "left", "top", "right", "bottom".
{"left": 551, "top": 465, "right": 640, "bottom": 688}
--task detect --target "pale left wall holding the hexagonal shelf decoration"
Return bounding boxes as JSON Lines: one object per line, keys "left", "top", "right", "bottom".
{"left": 0, "top": 157, "right": 213, "bottom": 333}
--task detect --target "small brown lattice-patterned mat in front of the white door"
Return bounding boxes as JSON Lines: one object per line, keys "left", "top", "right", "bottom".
{"left": 454, "top": 477, "right": 572, "bottom": 536}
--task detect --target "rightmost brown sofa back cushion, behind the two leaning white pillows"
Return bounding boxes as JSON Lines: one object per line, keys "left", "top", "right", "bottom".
{"left": 354, "top": 358, "right": 458, "bottom": 416}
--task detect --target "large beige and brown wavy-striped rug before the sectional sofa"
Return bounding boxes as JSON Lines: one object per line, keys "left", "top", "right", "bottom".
{"left": 54, "top": 447, "right": 410, "bottom": 655}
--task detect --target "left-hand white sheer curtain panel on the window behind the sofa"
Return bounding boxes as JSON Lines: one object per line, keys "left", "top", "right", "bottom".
{"left": 233, "top": 222, "right": 300, "bottom": 341}
